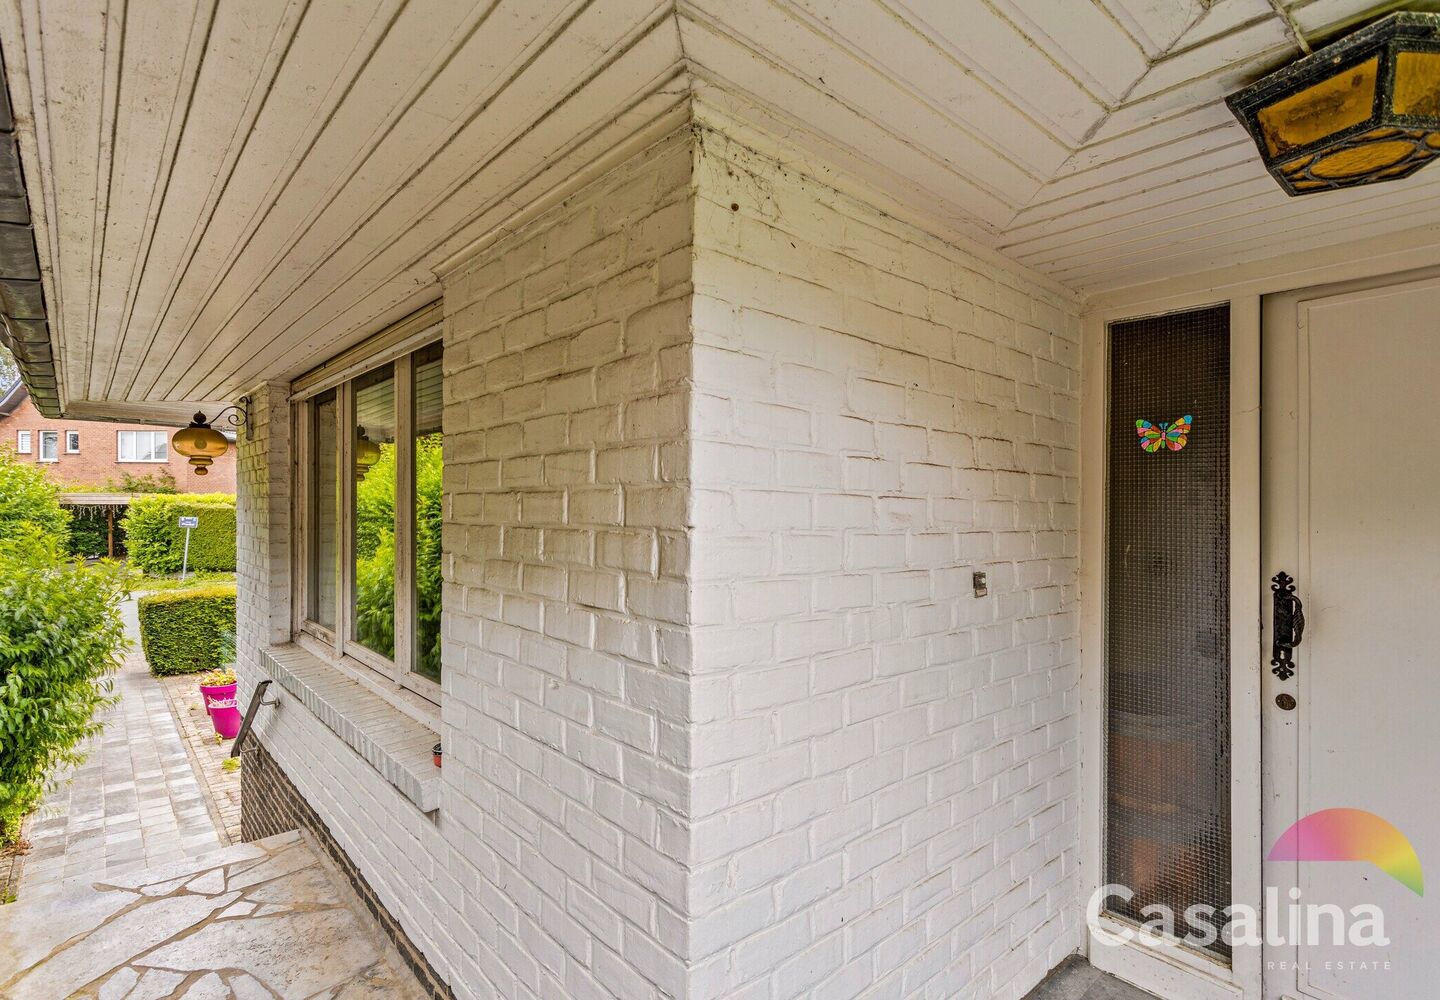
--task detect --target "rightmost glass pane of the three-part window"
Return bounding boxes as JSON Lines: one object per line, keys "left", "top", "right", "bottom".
{"left": 413, "top": 344, "right": 444, "bottom": 682}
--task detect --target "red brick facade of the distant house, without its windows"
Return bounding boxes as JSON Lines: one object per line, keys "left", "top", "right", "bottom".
{"left": 0, "top": 399, "right": 235, "bottom": 493}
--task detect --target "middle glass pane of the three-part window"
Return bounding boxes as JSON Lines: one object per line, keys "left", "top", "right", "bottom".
{"left": 351, "top": 365, "right": 396, "bottom": 660}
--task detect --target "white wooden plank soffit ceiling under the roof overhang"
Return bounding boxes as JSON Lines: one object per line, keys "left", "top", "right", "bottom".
{"left": 0, "top": 0, "right": 1440, "bottom": 415}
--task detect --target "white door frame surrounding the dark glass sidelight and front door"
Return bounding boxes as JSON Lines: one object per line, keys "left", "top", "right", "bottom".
{"left": 1076, "top": 228, "right": 1440, "bottom": 1000}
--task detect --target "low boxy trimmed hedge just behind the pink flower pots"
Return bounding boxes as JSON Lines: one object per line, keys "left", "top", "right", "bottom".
{"left": 140, "top": 584, "right": 235, "bottom": 677}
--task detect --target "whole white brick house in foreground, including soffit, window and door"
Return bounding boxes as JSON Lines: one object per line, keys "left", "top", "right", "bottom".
{"left": 0, "top": 0, "right": 1440, "bottom": 1000}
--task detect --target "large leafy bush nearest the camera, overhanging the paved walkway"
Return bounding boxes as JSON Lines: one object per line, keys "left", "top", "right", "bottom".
{"left": 0, "top": 533, "right": 130, "bottom": 841}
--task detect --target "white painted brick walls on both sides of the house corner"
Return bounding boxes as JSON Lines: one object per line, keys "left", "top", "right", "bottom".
{"left": 239, "top": 109, "right": 1080, "bottom": 1000}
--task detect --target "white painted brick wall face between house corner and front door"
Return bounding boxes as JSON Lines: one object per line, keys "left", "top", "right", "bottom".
{"left": 690, "top": 113, "right": 1080, "bottom": 1000}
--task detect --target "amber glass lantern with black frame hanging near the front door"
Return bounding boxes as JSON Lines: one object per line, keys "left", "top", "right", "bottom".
{"left": 1225, "top": 13, "right": 1440, "bottom": 195}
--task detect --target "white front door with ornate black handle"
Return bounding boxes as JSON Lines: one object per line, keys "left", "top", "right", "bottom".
{"left": 1261, "top": 278, "right": 1440, "bottom": 1000}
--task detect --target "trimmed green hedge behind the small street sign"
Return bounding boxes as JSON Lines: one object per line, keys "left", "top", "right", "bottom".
{"left": 124, "top": 493, "right": 235, "bottom": 576}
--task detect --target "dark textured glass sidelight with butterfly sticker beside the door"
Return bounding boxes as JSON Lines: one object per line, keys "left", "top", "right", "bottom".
{"left": 1104, "top": 307, "right": 1230, "bottom": 958}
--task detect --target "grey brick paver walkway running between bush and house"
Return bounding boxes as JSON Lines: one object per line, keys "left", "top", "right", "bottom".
{"left": 19, "top": 602, "right": 222, "bottom": 901}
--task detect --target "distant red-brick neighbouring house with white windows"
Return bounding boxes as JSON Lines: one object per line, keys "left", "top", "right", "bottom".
{"left": 0, "top": 382, "right": 235, "bottom": 493}
